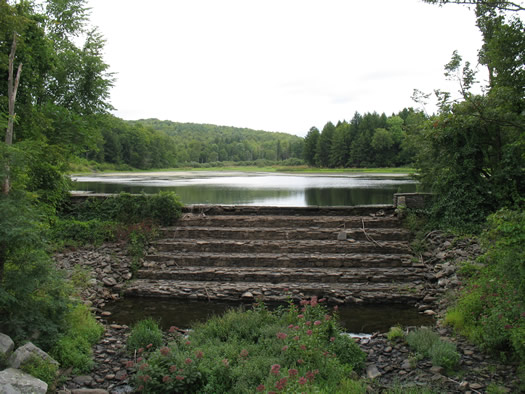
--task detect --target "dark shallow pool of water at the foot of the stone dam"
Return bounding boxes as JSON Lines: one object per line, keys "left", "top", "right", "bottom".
{"left": 104, "top": 297, "right": 434, "bottom": 334}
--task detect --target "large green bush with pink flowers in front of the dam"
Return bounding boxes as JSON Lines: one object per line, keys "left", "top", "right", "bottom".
{"left": 135, "top": 297, "right": 365, "bottom": 393}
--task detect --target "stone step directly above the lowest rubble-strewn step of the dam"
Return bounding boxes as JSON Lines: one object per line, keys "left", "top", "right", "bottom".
{"left": 137, "top": 266, "right": 425, "bottom": 283}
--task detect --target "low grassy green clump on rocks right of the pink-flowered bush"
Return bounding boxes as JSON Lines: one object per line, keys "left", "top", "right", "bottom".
{"left": 406, "top": 328, "right": 460, "bottom": 371}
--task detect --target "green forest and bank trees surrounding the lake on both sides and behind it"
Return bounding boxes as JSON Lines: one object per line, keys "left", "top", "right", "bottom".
{"left": 0, "top": 0, "right": 525, "bottom": 391}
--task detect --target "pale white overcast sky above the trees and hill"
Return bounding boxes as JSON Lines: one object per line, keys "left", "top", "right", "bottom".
{"left": 88, "top": 0, "right": 481, "bottom": 136}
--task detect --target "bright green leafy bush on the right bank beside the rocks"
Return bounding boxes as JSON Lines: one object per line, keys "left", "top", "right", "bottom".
{"left": 447, "top": 209, "right": 525, "bottom": 363}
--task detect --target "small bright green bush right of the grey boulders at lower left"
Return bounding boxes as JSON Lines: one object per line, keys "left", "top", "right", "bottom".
{"left": 51, "top": 304, "right": 104, "bottom": 373}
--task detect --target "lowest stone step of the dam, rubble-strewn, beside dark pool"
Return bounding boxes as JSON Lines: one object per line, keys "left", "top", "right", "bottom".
{"left": 124, "top": 279, "right": 424, "bottom": 303}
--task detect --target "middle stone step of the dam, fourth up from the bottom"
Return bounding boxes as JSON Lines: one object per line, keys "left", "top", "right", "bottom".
{"left": 152, "top": 239, "right": 410, "bottom": 254}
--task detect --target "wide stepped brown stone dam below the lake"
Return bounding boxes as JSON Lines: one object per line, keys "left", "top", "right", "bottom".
{"left": 124, "top": 205, "right": 433, "bottom": 304}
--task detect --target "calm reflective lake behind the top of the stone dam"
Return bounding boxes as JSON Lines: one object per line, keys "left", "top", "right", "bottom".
{"left": 72, "top": 171, "right": 417, "bottom": 207}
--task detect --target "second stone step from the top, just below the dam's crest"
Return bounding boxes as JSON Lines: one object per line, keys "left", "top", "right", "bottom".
{"left": 177, "top": 214, "right": 401, "bottom": 230}
